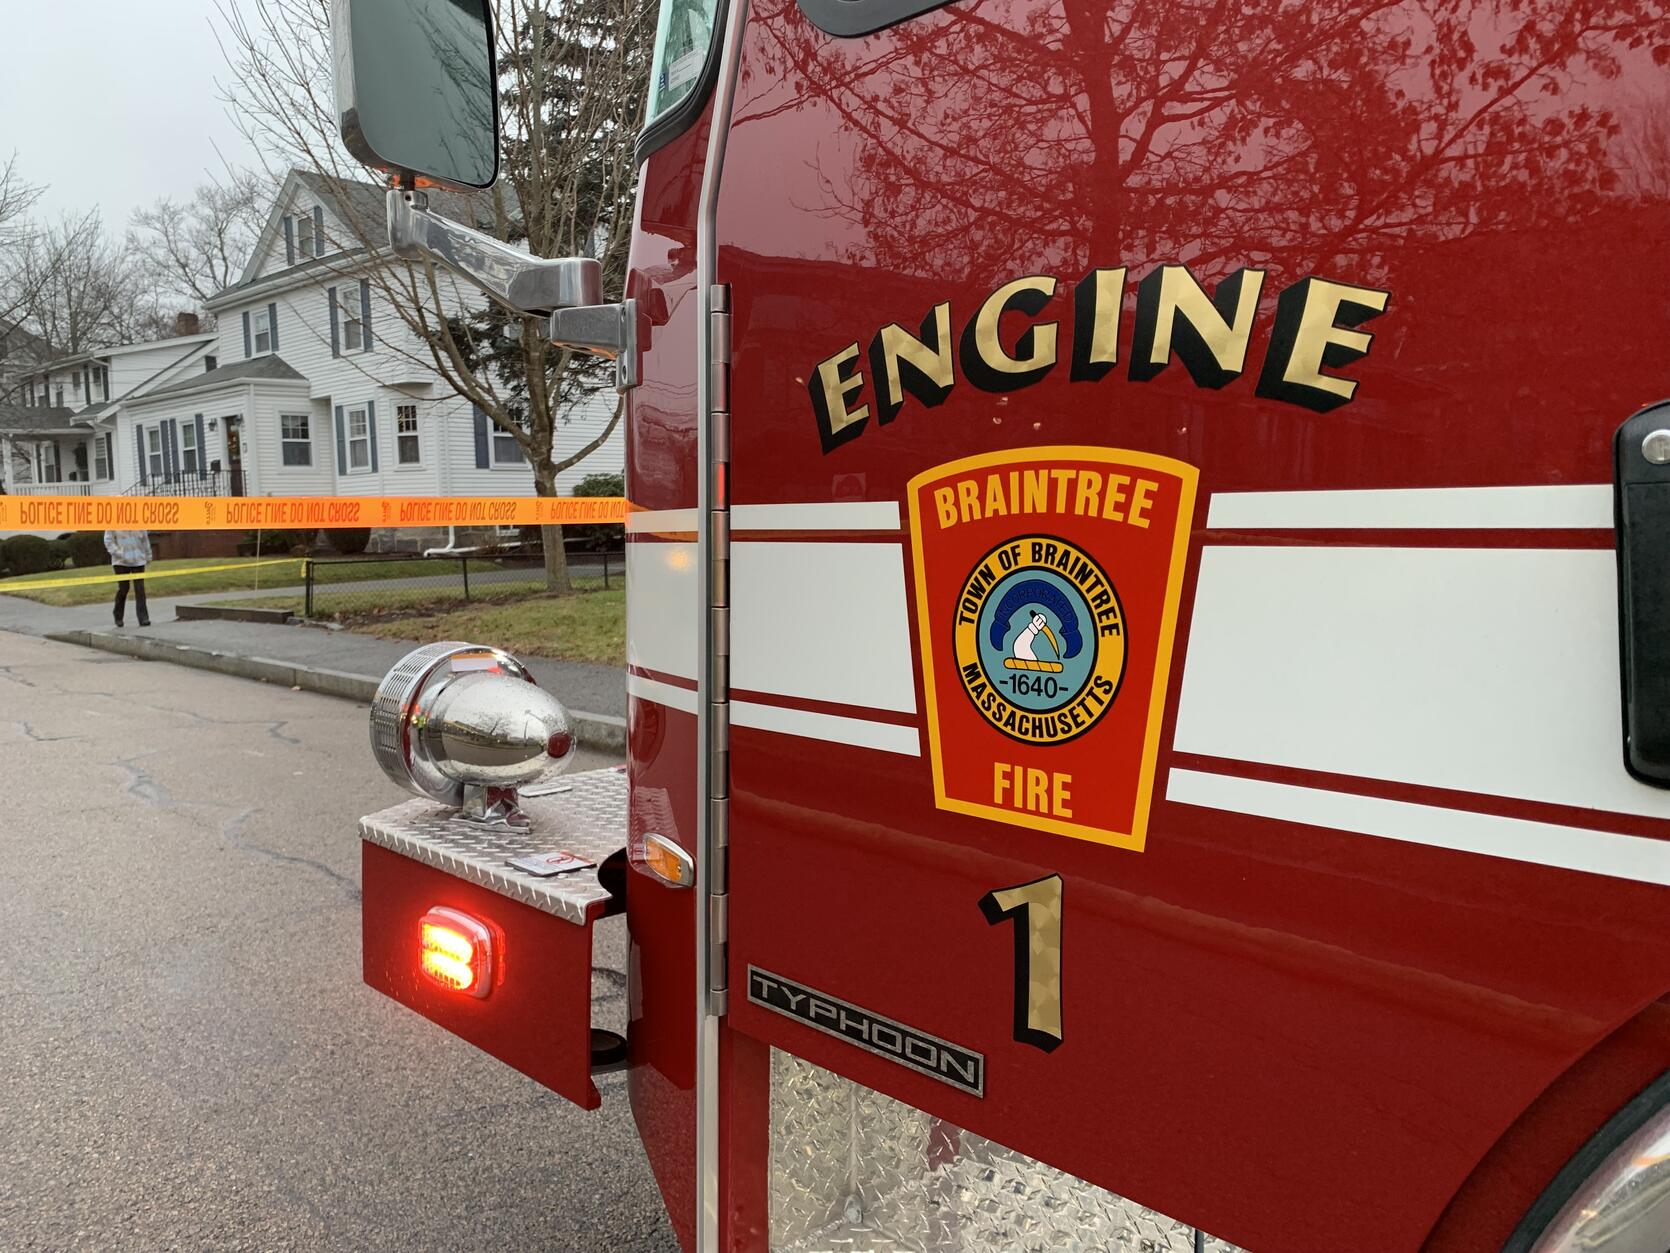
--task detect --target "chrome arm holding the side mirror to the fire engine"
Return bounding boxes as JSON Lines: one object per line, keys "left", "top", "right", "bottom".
{"left": 387, "top": 189, "right": 638, "bottom": 391}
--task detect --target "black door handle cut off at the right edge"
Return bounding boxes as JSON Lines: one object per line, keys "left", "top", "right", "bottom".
{"left": 1612, "top": 401, "right": 1670, "bottom": 787}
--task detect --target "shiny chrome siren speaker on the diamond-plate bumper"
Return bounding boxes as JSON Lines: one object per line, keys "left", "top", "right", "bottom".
{"left": 371, "top": 640, "right": 574, "bottom": 825}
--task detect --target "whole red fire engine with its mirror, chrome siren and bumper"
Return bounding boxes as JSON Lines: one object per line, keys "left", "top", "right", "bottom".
{"left": 336, "top": 0, "right": 1670, "bottom": 1253}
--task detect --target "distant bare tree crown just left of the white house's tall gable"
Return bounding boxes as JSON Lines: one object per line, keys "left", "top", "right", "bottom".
{"left": 127, "top": 169, "right": 274, "bottom": 309}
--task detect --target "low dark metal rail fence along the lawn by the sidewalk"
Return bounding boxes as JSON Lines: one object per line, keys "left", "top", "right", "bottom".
{"left": 302, "top": 548, "right": 626, "bottom": 618}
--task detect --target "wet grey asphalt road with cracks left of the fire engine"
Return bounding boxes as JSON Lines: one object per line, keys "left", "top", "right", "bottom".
{"left": 0, "top": 632, "right": 676, "bottom": 1253}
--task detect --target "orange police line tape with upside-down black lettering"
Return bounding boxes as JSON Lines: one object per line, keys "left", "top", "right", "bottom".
{"left": 0, "top": 496, "right": 626, "bottom": 531}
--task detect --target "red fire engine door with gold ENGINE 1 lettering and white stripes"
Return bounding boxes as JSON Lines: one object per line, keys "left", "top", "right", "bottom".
{"left": 715, "top": 0, "right": 1670, "bottom": 1248}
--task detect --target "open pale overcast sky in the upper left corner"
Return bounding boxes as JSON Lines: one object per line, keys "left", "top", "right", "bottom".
{"left": 0, "top": 0, "right": 262, "bottom": 232}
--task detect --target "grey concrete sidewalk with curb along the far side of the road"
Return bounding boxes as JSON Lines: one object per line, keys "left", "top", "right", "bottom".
{"left": 0, "top": 590, "right": 626, "bottom": 750}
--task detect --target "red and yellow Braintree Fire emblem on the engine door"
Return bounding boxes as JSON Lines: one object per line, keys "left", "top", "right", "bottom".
{"left": 910, "top": 448, "right": 1197, "bottom": 849}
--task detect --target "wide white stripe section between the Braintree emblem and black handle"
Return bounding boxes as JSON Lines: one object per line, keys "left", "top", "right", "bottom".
{"left": 1174, "top": 546, "right": 1670, "bottom": 819}
